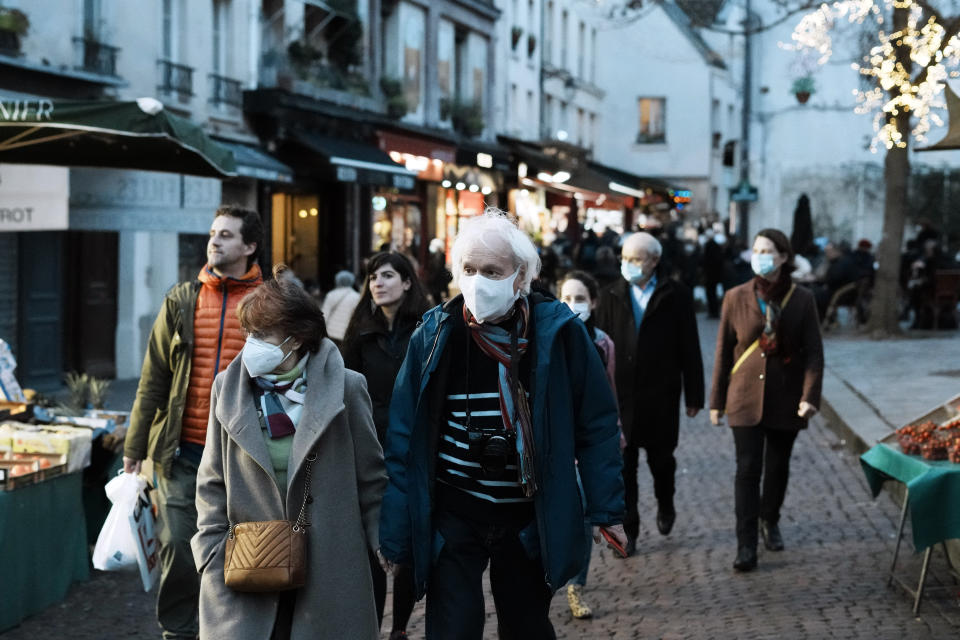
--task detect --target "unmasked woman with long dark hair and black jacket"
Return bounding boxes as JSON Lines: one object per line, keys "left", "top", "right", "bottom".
{"left": 342, "top": 252, "right": 428, "bottom": 640}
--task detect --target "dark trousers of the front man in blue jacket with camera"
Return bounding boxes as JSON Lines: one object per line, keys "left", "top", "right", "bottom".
{"left": 426, "top": 512, "right": 556, "bottom": 640}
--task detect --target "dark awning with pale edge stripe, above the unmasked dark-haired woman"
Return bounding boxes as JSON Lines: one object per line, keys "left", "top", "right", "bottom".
{"left": 291, "top": 131, "right": 417, "bottom": 189}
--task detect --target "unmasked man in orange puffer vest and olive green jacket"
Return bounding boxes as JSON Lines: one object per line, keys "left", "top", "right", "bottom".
{"left": 123, "top": 206, "right": 263, "bottom": 638}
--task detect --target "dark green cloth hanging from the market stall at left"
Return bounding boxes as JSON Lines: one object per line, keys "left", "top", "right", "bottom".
{"left": 0, "top": 473, "right": 90, "bottom": 632}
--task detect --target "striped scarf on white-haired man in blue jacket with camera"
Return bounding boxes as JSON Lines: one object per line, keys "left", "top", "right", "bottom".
{"left": 463, "top": 297, "right": 537, "bottom": 497}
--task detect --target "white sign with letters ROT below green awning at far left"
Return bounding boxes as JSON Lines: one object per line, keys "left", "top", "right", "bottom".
{"left": 0, "top": 164, "right": 70, "bottom": 232}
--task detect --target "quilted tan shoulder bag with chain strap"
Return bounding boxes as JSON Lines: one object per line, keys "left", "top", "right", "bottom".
{"left": 223, "top": 452, "right": 317, "bottom": 592}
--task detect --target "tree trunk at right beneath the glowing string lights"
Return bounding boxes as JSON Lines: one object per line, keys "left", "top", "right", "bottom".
{"left": 867, "top": 8, "right": 911, "bottom": 338}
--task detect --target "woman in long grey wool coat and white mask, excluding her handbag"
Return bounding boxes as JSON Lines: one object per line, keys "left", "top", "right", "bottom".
{"left": 192, "top": 267, "right": 387, "bottom": 640}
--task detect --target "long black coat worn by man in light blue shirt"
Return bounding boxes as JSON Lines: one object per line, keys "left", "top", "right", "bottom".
{"left": 593, "top": 269, "right": 704, "bottom": 448}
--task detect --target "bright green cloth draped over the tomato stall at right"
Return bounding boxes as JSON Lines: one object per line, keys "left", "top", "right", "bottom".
{"left": 860, "top": 444, "right": 960, "bottom": 551}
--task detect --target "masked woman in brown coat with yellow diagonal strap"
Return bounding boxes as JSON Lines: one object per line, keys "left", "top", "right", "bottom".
{"left": 710, "top": 229, "right": 823, "bottom": 571}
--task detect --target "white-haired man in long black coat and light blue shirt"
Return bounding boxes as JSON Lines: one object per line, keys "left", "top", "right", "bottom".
{"left": 593, "top": 232, "right": 704, "bottom": 554}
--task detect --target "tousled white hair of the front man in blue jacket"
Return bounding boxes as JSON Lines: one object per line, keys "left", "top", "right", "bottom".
{"left": 450, "top": 207, "right": 540, "bottom": 294}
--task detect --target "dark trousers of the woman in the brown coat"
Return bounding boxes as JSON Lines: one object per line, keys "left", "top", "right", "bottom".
{"left": 733, "top": 425, "right": 797, "bottom": 548}
